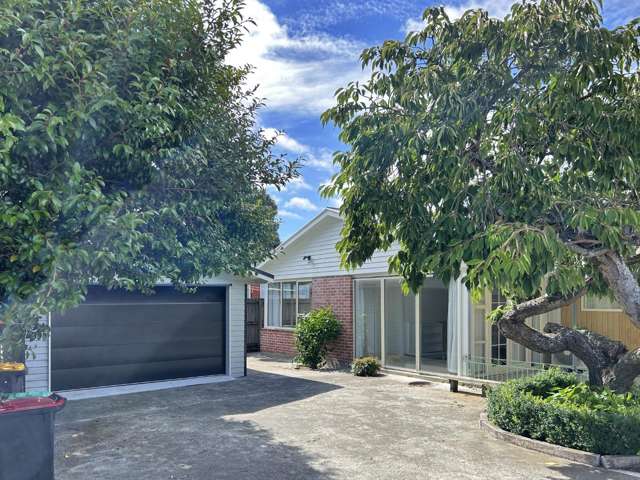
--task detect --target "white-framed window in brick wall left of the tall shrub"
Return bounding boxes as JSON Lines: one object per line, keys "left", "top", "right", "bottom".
{"left": 267, "top": 281, "right": 311, "bottom": 328}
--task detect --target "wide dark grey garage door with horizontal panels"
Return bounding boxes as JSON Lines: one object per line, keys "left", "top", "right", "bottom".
{"left": 51, "top": 287, "right": 226, "bottom": 390}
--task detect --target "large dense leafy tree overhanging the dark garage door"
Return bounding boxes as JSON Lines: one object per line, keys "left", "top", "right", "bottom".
{"left": 0, "top": 0, "right": 296, "bottom": 359}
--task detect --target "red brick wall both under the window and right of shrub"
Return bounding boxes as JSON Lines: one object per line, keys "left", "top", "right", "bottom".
{"left": 260, "top": 276, "right": 353, "bottom": 363}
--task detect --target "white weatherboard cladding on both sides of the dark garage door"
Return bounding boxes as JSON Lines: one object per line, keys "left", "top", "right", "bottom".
{"left": 26, "top": 275, "right": 247, "bottom": 391}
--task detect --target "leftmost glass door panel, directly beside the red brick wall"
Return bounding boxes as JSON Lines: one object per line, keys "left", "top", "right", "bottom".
{"left": 355, "top": 279, "right": 382, "bottom": 358}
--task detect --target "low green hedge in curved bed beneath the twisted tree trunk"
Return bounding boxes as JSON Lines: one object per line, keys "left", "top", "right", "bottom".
{"left": 487, "top": 369, "right": 640, "bottom": 455}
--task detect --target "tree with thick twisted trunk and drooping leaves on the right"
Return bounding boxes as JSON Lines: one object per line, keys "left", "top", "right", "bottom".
{"left": 323, "top": 0, "right": 640, "bottom": 391}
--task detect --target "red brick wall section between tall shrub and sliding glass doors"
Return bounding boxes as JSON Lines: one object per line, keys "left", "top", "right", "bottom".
{"left": 311, "top": 276, "right": 353, "bottom": 363}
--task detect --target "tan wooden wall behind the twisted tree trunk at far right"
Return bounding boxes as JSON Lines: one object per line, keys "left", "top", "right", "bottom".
{"left": 562, "top": 300, "right": 640, "bottom": 349}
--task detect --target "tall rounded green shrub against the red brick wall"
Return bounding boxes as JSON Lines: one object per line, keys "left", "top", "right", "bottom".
{"left": 295, "top": 307, "right": 340, "bottom": 370}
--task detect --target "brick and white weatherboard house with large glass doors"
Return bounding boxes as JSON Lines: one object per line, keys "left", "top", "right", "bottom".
{"left": 260, "top": 208, "right": 640, "bottom": 379}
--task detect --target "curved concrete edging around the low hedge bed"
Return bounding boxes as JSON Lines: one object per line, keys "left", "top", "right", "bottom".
{"left": 480, "top": 413, "right": 640, "bottom": 469}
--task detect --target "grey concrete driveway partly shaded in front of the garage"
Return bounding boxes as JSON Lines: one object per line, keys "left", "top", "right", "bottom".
{"left": 56, "top": 356, "right": 633, "bottom": 480}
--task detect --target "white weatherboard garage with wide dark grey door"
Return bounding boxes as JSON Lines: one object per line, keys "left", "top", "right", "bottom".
{"left": 26, "top": 275, "right": 256, "bottom": 396}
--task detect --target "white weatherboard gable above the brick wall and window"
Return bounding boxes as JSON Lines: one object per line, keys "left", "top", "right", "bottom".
{"left": 260, "top": 216, "right": 398, "bottom": 280}
